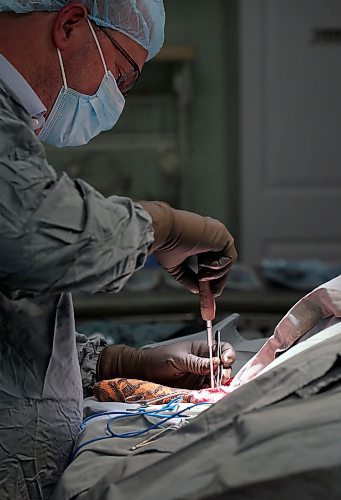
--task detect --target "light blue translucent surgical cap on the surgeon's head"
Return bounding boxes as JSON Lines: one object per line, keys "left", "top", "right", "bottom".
{"left": 0, "top": 0, "right": 165, "bottom": 60}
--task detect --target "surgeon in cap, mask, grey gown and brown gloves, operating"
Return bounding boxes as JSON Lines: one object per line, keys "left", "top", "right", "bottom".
{"left": 0, "top": 0, "right": 236, "bottom": 500}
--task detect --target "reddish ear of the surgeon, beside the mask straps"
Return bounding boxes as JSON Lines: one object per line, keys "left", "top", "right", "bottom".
{"left": 52, "top": 2, "right": 88, "bottom": 50}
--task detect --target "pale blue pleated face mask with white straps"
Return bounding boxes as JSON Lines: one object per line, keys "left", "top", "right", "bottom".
{"left": 38, "top": 20, "right": 125, "bottom": 147}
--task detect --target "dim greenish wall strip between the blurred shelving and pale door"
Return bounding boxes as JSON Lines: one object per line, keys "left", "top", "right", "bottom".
{"left": 165, "top": 0, "right": 238, "bottom": 234}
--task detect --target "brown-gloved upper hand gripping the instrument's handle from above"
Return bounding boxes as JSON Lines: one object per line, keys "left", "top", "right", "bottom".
{"left": 139, "top": 201, "right": 237, "bottom": 297}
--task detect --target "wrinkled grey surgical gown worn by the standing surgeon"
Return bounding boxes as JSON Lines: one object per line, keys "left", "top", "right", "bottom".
{"left": 0, "top": 81, "right": 153, "bottom": 500}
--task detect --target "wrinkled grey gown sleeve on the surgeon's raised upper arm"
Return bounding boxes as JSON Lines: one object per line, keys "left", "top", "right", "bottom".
{"left": 0, "top": 80, "right": 153, "bottom": 293}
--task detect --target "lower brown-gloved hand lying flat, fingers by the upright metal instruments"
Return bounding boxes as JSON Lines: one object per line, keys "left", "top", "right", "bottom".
{"left": 97, "top": 340, "right": 235, "bottom": 389}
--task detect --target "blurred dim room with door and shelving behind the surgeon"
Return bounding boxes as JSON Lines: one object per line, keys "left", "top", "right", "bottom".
{"left": 48, "top": 0, "right": 341, "bottom": 345}
